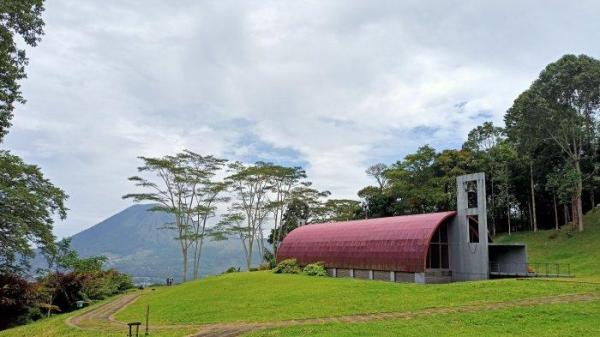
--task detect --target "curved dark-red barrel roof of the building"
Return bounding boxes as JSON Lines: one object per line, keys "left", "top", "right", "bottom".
{"left": 277, "top": 211, "right": 456, "bottom": 272}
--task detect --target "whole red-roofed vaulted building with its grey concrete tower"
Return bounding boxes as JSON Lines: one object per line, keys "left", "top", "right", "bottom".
{"left": 277, "top": 173, "right": 528, "bottom": 283}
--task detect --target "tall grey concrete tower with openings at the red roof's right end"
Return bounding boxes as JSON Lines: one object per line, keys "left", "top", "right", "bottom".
{"left": 448, "top": 173, "right": 489, "bottom": 281}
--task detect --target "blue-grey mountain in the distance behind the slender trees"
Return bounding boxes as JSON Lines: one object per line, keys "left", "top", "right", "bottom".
{"left": 41, "top": 205, "right": 258, "bottom": 282}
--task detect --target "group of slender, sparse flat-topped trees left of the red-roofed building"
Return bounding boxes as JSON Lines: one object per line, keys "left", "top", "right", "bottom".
{"left": 123, "top": 150, "right": 360, "bottom": 281}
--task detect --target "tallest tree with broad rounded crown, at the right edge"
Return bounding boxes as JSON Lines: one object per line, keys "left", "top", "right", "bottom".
{"left": 507, "top": 55, "right": 600, "bottom": 231}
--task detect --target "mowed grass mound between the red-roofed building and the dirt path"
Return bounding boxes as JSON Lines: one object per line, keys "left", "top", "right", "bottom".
{"left": 116, "top": 271, "right": 600, "bottom": 324}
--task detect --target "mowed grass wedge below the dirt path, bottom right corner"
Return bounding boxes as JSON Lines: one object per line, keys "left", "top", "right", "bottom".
{"left": 244, "top": 301, "right": 600, "bottom": 337}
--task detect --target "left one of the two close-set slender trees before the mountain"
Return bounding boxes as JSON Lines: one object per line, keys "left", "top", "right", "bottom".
{"left": 123, "top": 153, "right": 196, "bottom": 282}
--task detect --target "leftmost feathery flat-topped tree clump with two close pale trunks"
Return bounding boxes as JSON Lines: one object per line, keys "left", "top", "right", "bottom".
{"left": 123, "top": 150, "right": 227, "bottom": 281}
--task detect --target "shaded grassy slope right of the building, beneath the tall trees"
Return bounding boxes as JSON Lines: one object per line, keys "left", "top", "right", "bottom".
{"left": 496, "top": 208, "right": 600, "bottom": 281}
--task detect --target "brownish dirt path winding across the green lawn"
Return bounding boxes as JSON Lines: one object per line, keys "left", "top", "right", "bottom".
{"left": 66, "top": 293, "right": 600, "bottom": 337}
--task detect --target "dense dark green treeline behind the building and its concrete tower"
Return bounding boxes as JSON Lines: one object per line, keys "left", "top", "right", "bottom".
{"left": 358, "top": 55, "right": 600, "bottom": 235}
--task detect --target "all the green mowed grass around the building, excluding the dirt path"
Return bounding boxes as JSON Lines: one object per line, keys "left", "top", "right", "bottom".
{"left": 0, "top": 206, "right": 600, "bottom": 337}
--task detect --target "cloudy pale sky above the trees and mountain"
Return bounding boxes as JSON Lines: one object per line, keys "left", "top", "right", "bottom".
{"left": 2, "top": 0, "right": 600, "bottom": 237}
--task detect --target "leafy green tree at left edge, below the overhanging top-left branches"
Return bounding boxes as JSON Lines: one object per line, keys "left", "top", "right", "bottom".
{"left": 0, "top": 151, "right": 67, "bottom": 271}
